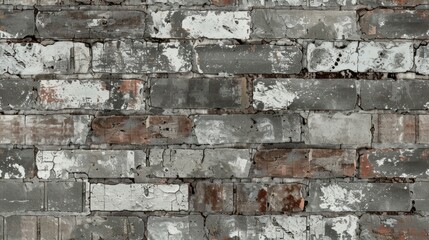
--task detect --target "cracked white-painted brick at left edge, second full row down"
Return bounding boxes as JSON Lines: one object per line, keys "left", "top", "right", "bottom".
{"left": 0, "top": 42, "right": 90, "bottom": 75}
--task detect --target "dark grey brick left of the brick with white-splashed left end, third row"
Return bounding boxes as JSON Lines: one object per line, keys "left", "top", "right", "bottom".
{"left": 150, "top": 78, "right": 249, "bottom": 109}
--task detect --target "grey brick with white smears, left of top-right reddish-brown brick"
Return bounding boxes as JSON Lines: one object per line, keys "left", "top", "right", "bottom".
{"left": 251, "top": 9, "right": 359, "bottom": 40}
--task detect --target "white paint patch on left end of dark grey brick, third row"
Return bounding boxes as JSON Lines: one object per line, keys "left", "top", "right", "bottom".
{"left": 253, "top": 81, "right": 298, "bottom": 110}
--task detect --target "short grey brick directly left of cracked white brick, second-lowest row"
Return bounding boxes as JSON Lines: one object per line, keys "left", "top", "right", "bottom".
{"left": 45, "top": 182, "right": 86, "bottom": 212}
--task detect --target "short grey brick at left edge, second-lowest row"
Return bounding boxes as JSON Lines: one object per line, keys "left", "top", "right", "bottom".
{"left": 0, "top": 180, "right": 44, "bottom": 213}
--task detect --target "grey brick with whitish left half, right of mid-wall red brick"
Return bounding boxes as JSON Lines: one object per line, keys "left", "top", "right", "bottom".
{"left": 193, "top": 114, "right": 301, "bottom": 145}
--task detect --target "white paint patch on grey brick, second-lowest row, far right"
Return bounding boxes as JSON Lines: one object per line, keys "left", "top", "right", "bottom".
{"left": 320, "top": 183, "right": 364, "bottom": 212}
